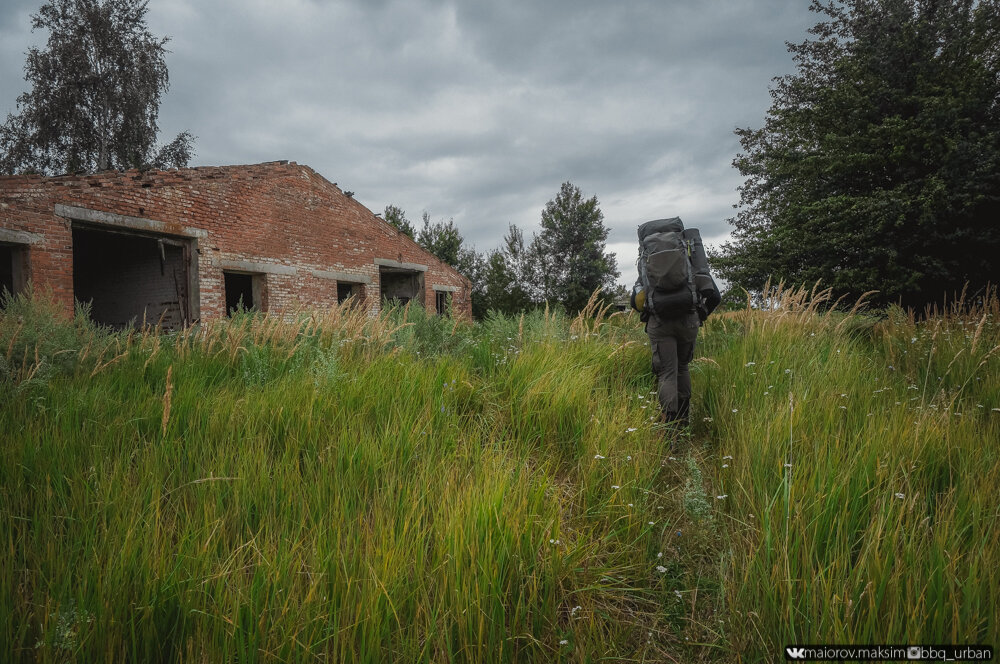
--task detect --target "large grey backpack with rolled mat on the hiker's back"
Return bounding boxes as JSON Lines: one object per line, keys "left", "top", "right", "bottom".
{"left": 632, "top": 217, "right": 716, "bottom": 318}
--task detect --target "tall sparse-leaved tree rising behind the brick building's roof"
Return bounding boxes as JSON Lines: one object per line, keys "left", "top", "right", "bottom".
{"left": 0, "top": 0, "right": 194, "bottom": 174}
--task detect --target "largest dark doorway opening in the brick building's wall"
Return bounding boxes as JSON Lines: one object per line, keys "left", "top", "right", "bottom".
{"left": 73, "top": 225, "right": 191, "bottom": 330}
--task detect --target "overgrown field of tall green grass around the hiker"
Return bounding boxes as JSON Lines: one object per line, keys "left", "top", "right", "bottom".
{"left": 0, "top": 292, "right": 1000, "bottom": 662}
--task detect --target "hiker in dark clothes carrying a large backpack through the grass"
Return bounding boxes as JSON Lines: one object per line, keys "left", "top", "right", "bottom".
{"left": 631, "top": 217, "right": 722, "bottom": 427}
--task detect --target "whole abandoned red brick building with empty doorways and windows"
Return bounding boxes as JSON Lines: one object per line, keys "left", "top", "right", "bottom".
{"left": 0, "top": 162, "right": 471, "bottom": 328}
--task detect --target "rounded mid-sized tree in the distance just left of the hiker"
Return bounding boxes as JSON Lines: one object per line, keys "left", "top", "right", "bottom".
{"left": 527, "top": 182, "right": 619, "bottom": 312}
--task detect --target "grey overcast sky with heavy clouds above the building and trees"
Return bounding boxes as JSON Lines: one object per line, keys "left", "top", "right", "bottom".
{"left": 0, "top": 0, "right": 817, "bottom": 285}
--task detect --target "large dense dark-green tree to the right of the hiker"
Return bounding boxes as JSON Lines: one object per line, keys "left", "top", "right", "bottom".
{"left": 713, "top": 0, "right": 1000, "bottom": 305}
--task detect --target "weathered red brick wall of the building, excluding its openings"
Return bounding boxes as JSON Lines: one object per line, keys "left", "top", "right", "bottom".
{"left": 0, "top": 162, "right": 471, "bottom": 318}
